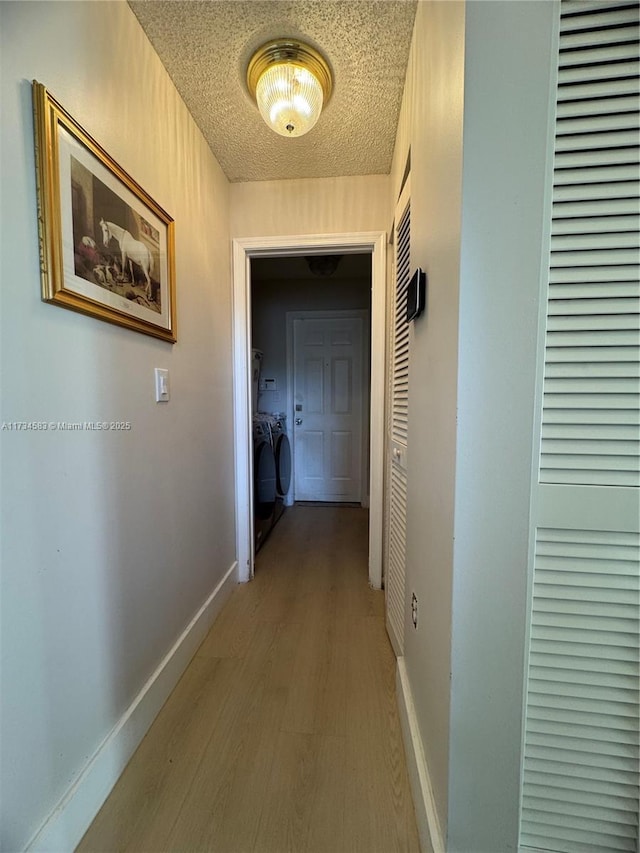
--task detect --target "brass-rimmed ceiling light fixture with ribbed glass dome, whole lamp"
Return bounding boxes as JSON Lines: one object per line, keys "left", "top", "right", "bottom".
{"left": 247, "top": 39, "right": 333, "bottom": 136}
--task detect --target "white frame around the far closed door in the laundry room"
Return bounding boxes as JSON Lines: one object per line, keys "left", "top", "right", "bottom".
{"left": 286, "top": 308, "right": 371, "bottom": 506}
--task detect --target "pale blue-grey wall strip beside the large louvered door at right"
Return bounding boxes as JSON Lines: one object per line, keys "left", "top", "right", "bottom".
{"left": 449, "top": 0, "right": 558, "bottom": 853}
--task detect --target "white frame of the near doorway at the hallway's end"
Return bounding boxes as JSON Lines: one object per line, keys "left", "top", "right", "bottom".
{"left": 232, "top": 231, "right": 387, "bottom": 589}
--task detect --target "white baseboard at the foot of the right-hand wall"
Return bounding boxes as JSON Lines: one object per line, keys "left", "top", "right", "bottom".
{"left": 396, "top": 658, "right": 446, "bottom": 853}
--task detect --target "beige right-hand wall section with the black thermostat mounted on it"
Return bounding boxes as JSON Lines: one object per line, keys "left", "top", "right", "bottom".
{"left": 392, "top": 2, "right": 464, "bottom": 828}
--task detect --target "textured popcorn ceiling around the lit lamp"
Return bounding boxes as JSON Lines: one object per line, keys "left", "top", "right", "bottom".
{"left": 129, "top": 0, "right": 416, "bottom": 181}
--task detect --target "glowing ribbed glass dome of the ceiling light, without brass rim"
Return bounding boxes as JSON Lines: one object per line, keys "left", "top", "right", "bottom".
{"left": 256, "top": 63, "right": 324, "bottom": 136}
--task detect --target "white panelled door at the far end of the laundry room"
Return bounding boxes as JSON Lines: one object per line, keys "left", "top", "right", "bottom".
{"left": 293, "top": 316, "right": 364, "bottom": 502}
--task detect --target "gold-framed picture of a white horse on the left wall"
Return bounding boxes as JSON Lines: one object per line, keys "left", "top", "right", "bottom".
{"left": 33, "top": 80, "right": 176, "bottom": 343}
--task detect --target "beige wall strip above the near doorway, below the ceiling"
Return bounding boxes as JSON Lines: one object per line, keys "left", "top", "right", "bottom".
{"left": 230, "top": 175, "right": 392, "bottom": 237}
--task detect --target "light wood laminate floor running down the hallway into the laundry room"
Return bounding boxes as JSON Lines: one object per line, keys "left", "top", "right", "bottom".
{"left": 77, "top": 506, "right": 419, "bottom": 853}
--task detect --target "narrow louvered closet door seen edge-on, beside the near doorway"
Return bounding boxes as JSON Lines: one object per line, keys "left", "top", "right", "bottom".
{"left": 385, "top": 179, "right": 411, "bottom": 656}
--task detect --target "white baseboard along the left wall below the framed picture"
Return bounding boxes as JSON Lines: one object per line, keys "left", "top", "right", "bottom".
{"left": 26, "top": 562, "right": 238, "bottom": 853}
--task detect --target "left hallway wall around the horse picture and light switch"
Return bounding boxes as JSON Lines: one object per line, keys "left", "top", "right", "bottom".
{"left": 0, "top": 2, "right": 235, "bottom": 851}
